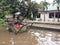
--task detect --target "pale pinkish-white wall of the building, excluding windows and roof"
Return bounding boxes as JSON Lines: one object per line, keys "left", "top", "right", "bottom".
{"left": 36, "top": 12, "right": 60, "bottom": 22}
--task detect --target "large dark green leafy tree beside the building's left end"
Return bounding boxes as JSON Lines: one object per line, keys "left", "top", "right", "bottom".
{"left": 20, "top": 1, "right": 41, "bottom": 19}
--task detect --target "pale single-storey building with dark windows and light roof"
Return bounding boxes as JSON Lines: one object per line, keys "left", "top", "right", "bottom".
{"left": 32, "top": 5, "right": 60, "bottom": 22}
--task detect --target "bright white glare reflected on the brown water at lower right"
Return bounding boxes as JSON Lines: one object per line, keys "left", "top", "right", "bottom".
{"left": 31, "top": 29, "right": 60, "bottom": 45}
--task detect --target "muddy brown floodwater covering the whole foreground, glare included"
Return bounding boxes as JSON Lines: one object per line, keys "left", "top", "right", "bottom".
{"left": 0, "top": 28, "right": 60, "bottom": 45}
